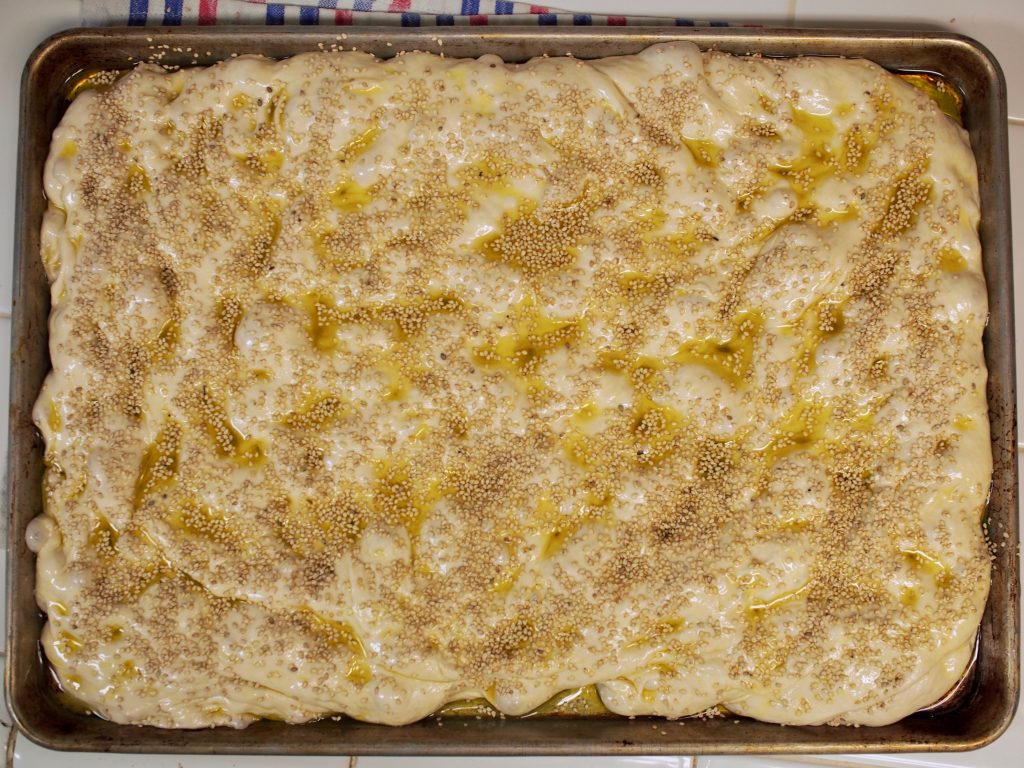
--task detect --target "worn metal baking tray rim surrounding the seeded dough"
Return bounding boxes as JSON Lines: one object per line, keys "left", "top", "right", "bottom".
{"left": 6, "top": 27, "right": 1020, "bottom": 755}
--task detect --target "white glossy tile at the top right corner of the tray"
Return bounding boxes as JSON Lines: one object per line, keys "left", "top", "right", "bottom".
{"left": 795, "top": 0, "right": 1024, "bottom": 119}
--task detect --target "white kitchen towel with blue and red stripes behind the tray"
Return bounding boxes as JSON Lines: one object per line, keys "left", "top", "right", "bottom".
{"left": 82, "top": 0, "right": 729, "bottom": 27}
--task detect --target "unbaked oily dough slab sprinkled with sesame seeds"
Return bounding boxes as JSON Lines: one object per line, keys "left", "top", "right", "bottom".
{"left": 31, "top": 43, "right": 991, "bottom": 727}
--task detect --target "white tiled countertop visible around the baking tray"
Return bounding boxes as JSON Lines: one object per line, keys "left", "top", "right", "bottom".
{"left": 0, "top": 0, "right": 1024, "bottom": 768}
